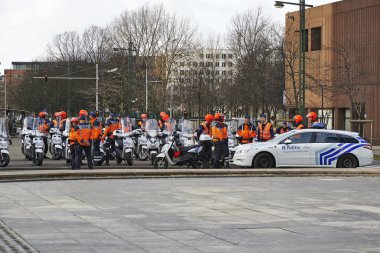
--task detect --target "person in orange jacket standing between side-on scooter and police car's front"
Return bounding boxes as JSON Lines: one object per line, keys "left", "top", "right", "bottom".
{"left": 211, "top": 113, "right": 228, "bottom": 168}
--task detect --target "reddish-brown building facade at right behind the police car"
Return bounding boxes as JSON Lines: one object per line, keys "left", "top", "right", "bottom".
{"left": 286, "top": 0, "right": 380, "bottom": 144}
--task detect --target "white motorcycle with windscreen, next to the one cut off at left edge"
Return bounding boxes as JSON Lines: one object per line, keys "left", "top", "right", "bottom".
{"left": 24, "top": 117, "right": 47, "bottom": 166}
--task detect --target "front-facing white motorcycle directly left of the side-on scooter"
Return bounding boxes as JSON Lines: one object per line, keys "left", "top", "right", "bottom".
{"left": 145, "top": 119, "right": 160, "bottom": 165}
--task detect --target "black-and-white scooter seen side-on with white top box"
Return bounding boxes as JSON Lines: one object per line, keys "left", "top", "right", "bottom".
{"left": 153, "top": 129, "right": 211, "bottom": 169}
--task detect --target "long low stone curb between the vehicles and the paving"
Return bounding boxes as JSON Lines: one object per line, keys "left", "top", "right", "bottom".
{"left": 0, "top": 168, "right": 380, "bottom": 182}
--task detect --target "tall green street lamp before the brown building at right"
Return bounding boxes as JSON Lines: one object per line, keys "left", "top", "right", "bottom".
{"left": 274, "top": 0, "right": 313, "bottom": 119}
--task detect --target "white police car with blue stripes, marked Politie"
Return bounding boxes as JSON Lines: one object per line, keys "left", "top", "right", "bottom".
{"left": 232, "top": 129, "right": 373, "bottom": 168}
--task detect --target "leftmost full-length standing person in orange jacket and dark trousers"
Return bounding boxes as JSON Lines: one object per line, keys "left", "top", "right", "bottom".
{"left": 74, "top": 116, "right": 93, "bottom": 170}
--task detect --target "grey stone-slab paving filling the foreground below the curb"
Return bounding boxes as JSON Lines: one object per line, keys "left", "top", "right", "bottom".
{"left": 0, "top": 177, "right": 380, "bottom": 253}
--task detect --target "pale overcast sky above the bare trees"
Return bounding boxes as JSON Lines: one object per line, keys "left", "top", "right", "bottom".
{"left": 0, "top": 0, "right": 336, "bottom": 74}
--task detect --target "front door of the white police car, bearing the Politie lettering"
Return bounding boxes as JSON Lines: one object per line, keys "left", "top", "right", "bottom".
{"left": 276, "top": 132, "right": 313, "bottom": 166}
